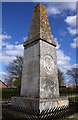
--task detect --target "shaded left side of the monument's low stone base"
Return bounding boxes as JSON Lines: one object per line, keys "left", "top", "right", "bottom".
{"left": 11, "top": 97, "right": 39, "bottom": 110}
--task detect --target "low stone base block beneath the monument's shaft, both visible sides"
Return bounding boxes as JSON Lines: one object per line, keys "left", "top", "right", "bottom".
{"left": 11, "top": 97, "right": 69, "bottom": 112}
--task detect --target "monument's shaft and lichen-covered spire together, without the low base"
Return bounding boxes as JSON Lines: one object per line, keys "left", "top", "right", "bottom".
{"left": 21, "top": 4, "right": 59, "bottom": 98}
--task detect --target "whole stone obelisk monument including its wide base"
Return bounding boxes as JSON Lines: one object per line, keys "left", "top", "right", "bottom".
{"left": 11, "top": 4, "right": 68, "bottom": 111}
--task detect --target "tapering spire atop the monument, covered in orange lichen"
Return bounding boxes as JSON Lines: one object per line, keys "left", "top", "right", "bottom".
{"left": 25, "top": 3, "right": 55, "bottom": 45}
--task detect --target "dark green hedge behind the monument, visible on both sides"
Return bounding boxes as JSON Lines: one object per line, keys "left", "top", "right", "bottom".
{"left": 0, "top": 87, "right": 78, "bottom": 100}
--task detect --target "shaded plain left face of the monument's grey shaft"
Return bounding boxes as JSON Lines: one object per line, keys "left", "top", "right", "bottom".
{"left": 21, "top": 42, "right": 40, "bottom": 98}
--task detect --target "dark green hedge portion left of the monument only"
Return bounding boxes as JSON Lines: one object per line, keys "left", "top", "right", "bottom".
{"left": 2, "top": 88, "right": 20, "bottom": 100}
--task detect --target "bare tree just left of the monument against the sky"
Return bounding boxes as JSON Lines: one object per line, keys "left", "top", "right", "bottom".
{"left": 5, "top": 56, "right": 23, "bottom": 88}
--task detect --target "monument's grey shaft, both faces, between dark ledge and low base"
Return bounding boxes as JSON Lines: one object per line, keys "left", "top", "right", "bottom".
{"left": 21, "top": 40, "right": 59, "bottom": 98}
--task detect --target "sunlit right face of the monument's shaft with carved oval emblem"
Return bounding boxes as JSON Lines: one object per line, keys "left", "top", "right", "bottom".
{"left": 40, "top": 40, "right": 59, "bottom": 98}
